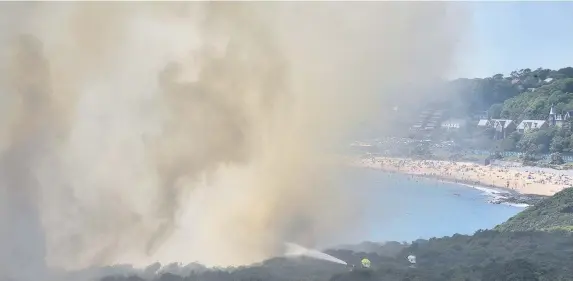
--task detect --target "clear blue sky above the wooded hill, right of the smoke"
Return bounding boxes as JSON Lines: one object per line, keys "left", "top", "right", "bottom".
{"left": 452, "top": 2, "right": 573, "bottom": 77}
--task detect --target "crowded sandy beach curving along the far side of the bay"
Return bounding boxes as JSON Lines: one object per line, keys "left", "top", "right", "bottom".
{"left": 353, "top": 157, "right": 573, "bottom": 196}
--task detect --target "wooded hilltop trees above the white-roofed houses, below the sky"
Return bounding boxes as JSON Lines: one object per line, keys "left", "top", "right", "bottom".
{"left": 449, "top": 67, "right": 573, "bottom": 115}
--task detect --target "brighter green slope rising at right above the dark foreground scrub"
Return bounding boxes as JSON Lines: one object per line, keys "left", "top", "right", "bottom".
{"left": 495, "top": 188, "right": 573, "bottom": 231}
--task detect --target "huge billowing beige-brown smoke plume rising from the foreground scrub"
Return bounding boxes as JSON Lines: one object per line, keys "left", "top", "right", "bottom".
{"left": 0, "top": 2, "right": 462, "bottom": 280}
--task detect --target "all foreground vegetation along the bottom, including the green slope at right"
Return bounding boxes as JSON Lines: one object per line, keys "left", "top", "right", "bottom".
{"left": 99, "top": 190, "right": 573, "bottom": 281}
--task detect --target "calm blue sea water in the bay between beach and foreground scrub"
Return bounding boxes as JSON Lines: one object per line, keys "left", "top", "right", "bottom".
{"left": 340, "top": 168, "right": 524, "bottom": 242}
